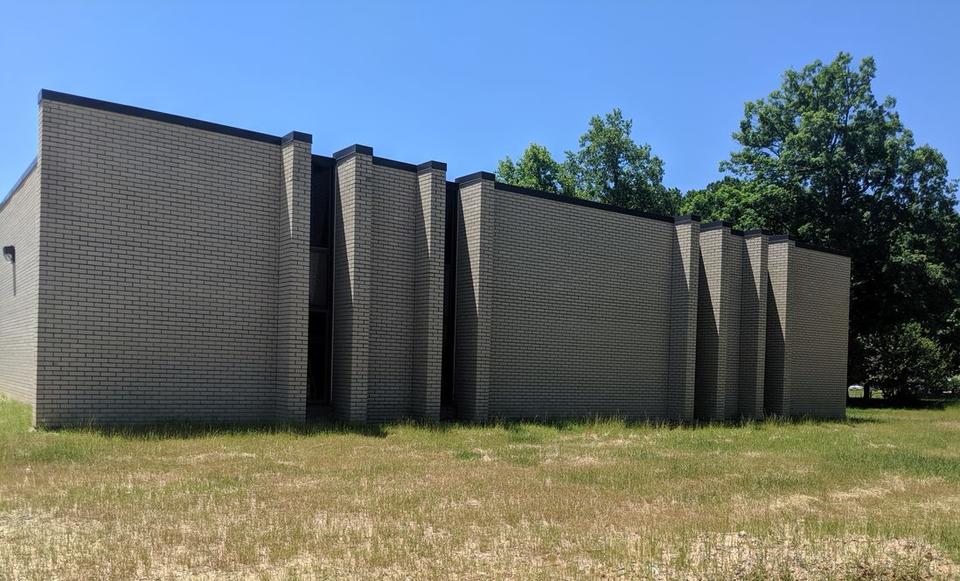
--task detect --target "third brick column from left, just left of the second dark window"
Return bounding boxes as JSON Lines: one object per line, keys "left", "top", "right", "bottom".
{"left": 411, "top": 161, "right": 447, "bottom": 421}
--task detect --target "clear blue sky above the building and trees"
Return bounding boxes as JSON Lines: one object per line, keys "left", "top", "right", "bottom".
{"left": 0, "top": 0, "right": 960, "bottom": 196}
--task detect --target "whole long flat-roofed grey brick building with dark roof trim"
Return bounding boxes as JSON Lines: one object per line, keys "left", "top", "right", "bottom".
{"left": 0, "top": 91, "right": 850, "bottom": 426}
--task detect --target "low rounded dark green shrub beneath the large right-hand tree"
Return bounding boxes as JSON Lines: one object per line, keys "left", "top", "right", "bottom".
{"left": 863, "top": 322, "right": 949, "bottom": 400}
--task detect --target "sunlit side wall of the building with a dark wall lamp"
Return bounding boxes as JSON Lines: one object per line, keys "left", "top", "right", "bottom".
{"left": 0, "top": 160, "right": 40, "bottom": 404}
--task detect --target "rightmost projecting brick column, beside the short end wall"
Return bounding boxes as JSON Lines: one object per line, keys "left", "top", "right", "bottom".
{"left": 763, "top": 237, "right": 794, "bottom": 416}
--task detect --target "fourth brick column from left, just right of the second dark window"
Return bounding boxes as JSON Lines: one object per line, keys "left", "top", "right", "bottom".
{"left": 455, "top": 172, "right": 496, "bottom": 421}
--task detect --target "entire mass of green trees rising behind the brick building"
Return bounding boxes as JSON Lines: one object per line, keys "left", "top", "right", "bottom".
{"left": 498, "top": 53, "right": 960, "bottom": 395}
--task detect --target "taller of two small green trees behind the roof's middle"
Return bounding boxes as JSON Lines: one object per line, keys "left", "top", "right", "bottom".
{"left": 564, "top": 109, "right": 680, "bottom": 214}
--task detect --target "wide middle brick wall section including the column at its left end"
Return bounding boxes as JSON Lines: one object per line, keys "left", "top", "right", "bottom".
{"left": 457, "top": 174, "right": 678, "bottom": 419}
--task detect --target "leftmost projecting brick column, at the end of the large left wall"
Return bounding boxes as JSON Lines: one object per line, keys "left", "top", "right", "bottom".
{"left": 276, "top": 131, "right": 312, "bottom": 422}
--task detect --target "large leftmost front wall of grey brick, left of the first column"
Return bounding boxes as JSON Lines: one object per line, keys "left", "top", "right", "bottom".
{"left": 36, "top": 100, "right": 309, "bottom": 425}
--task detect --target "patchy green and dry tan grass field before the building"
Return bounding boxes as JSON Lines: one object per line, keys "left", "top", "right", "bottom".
{"left": 0, "top": 399, "right": 960, "bottom": 579}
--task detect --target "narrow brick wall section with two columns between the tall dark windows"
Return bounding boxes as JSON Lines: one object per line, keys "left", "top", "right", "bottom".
{"left": 334, "top": 153, "right": 446, "bottom": 421}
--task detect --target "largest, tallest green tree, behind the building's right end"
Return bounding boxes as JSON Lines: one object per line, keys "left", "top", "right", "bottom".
{"left": 685, "top": 53, "right": 960, "bottom": 392}
